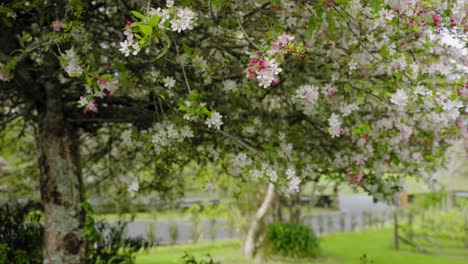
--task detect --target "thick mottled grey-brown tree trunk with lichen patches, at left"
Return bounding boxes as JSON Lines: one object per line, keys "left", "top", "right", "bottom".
{"left": 38, "top": 84, "right": 85, "bottom": 264}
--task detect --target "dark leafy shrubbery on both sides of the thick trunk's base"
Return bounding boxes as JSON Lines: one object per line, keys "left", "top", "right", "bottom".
{"left": 0, "top": 201, "right": 150, "bottom": 264}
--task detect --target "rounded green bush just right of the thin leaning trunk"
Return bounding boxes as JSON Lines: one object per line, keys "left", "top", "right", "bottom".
{"left": 266, "top": 223, "right": 319, "bottom": 258}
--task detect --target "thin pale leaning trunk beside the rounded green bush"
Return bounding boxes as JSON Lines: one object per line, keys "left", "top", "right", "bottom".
{"left": 244, "top": 183, "right": 275, "bottom": 260}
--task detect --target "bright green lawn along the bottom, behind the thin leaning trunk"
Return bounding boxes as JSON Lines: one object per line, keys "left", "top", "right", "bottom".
{"left": 136, "top": 229, "right": 468, "bottom": 264}
